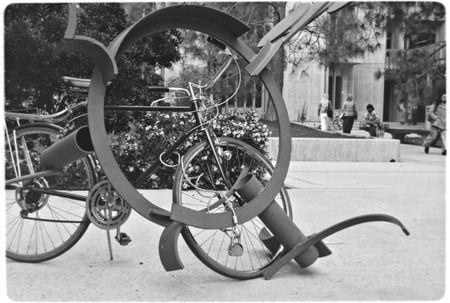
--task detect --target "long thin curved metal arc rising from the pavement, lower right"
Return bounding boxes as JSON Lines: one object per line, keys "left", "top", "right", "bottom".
{"left": 264, "top": 214, "right": 409, "bottom": 280}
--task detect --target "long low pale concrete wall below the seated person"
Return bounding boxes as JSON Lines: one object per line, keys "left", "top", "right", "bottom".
{"left": 268, "top": 138, "right": 400, "bottom": 162}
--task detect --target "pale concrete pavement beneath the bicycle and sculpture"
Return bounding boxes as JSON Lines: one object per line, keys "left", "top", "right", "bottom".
{"left": 6, "top": 144, "right": 446, "bottom": 301}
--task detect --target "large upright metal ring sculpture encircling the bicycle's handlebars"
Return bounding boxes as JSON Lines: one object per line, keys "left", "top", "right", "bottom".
{"left": 88, "top": 5, "right": 291, "bottom": 229}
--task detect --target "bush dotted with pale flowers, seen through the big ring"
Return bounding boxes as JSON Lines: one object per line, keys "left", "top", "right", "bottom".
{"left": 111, "top": 112, "right": 269, "bottom": 189}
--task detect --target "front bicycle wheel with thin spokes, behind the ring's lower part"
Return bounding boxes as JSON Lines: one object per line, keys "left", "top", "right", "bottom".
{"left": 173, "top": 138, "right": 292, "bottom": 280}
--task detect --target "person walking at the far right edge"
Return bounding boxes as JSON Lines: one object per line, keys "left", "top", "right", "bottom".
{"left": 423, "top": 94, "right": 447, "bottom": 156}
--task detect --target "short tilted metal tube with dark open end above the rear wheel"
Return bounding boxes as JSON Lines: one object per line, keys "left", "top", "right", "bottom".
{"left": 40, "top": 126, "right": 94, "bottom": 169}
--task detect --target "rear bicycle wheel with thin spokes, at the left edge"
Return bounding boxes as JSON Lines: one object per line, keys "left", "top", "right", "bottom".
{"left": 5, "top": 123, "right": 96, "bottom": 263}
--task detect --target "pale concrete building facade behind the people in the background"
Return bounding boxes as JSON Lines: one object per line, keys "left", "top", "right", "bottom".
{"left": 283, "top": 2, "right": 446, "bottom": 122}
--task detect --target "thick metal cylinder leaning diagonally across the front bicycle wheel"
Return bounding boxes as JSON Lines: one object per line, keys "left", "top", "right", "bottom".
{"left": 236, "top": 175, "right": 319, "bottom": 268}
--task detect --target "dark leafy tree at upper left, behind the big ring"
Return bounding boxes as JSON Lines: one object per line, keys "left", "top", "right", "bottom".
{"left": 5, "top": 3, "right": 180, "bottom": 119}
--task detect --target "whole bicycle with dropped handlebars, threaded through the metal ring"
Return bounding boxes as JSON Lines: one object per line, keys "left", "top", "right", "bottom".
{"left": 6, "top": 32, "right": 292, "bottom": 279}
